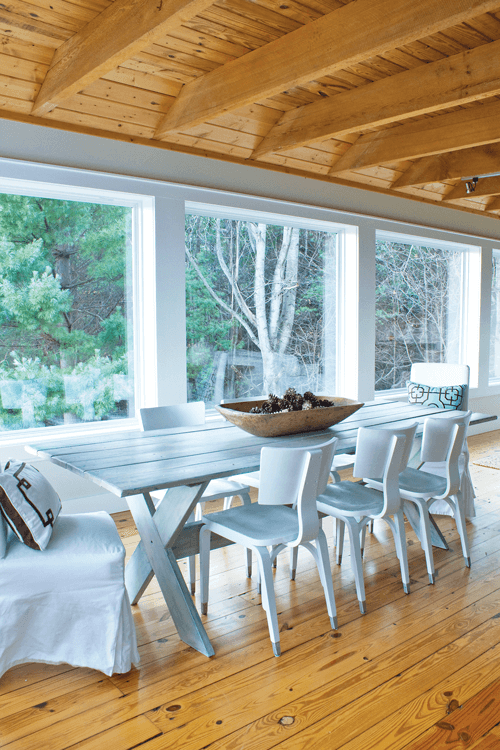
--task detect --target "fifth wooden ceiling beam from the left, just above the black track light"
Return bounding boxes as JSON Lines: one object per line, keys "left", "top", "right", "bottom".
{"left": 391, "top": 143, "right": 500, "bottom": 188}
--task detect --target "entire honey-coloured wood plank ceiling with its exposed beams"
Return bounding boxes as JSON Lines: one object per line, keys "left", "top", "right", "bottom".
{"left": 0, "top": 0, "right": 500, "bottom": 217}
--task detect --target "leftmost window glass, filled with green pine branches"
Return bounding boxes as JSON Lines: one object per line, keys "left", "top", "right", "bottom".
{"left": 0, "top": 194, "right": 134, "bottom": 430}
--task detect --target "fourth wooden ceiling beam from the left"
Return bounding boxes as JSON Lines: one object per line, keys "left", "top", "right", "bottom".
{"left": 330, "top": 102, "right": 500, "bottom": 174}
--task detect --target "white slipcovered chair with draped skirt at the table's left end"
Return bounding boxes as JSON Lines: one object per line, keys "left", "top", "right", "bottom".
{"left": 0, "top": 511, "right": 139, "bottom": 676}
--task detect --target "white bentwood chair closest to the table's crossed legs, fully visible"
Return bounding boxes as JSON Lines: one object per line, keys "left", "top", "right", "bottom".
{"left": 200, "top": 438, "right": 337, "bottom": 656}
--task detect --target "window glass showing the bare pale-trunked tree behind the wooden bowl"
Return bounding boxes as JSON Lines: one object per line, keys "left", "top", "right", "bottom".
{"left": 186, "top": 215, "right": 337, "bottom": 405}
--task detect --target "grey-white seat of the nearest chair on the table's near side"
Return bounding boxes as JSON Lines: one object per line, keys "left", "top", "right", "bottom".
{"left": 202, "top": 503, "right": 299, "bottom": 547}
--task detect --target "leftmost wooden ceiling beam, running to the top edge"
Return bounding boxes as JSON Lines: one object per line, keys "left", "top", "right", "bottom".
{"left": 33, "top": 0, "right": 213, "bottom": 117}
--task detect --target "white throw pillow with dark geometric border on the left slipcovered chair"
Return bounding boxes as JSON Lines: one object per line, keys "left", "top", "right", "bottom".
{"left": 0, "top": 460, "right": 61, "bottom": 550}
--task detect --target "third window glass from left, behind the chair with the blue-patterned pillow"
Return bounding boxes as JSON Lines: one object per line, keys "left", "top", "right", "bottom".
{"left": 375, "top": 240, "right": 462, "bottom": 391}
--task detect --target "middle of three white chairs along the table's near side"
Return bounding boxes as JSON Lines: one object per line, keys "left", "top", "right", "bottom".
{"left": 317, "top": 422, "right": 417, "bottom": 614}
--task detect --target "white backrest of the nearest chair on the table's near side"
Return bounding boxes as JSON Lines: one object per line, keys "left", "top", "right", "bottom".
{"left": 258, "top": 438, "right": 337, "bottom": 544}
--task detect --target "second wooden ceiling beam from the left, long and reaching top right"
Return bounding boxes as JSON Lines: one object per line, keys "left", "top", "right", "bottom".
{"left": 156, "top": 0, "right": 498, "bottom": 139}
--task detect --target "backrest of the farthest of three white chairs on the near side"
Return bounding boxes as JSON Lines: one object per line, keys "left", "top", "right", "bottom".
{"left": 420, "top": 411, "right": 472, "bottom": 495}
